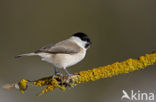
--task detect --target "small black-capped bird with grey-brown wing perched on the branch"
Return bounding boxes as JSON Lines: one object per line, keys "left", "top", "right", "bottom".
{"left": 15, "top": 32, "right": 91, "bottom": 76}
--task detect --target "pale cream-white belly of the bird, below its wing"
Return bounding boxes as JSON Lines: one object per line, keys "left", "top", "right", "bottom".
{"left": 52, "top": 53, "right": 85, "bottom": 68}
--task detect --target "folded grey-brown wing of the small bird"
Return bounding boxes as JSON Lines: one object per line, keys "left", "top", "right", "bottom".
{"left": 35, "top": 40, "right": 80, "bottom": 54}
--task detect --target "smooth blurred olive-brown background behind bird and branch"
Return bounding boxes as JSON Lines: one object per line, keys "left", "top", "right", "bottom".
{"left": 0, "top": 0, "right": 156, "bottom": 102}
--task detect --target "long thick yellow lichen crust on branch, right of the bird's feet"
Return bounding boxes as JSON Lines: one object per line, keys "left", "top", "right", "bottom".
{"left": 76, "top": 53, "right": 156, "bottom": 83}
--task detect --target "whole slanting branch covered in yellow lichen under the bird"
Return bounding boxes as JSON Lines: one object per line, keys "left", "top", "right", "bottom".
{"left": 4, "top": 52, "right": 156, "bottom": 95}
